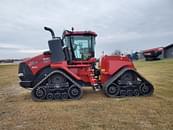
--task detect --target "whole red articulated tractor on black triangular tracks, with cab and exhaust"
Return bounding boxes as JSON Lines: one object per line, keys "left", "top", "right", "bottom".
{"left": 18, "top": 27, "right": 154, "bottom": 101}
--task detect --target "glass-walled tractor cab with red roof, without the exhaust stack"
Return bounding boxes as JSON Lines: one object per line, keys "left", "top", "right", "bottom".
{"left": 62, "top": 29, "right": 97, "bottom": 61}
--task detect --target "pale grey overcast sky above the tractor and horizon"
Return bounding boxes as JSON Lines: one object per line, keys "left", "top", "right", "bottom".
{"left": 0, "top": 0, "right": 173, "bottom": 59}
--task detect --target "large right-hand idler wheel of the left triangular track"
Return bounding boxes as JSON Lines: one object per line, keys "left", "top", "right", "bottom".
{"left": 68, "top": 84, "right": 83, "bottom": 99}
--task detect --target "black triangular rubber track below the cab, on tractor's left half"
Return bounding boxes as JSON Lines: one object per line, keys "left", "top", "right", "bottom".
{"left": 31, "top": 70, "right": 83, "bottom": 101}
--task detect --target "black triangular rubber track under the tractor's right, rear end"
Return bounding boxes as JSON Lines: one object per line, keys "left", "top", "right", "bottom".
{"left": 103, "top": 68, "right": 154, "bottom": 97}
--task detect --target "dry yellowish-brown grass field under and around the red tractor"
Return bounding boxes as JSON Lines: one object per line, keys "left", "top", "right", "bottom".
{"left": 0, "top": 60, "right": 173, "bottom": 130}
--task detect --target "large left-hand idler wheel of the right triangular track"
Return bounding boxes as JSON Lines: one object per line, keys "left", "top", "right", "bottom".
{"left": 105, "top": 83, "right": 120, "bottom": 97}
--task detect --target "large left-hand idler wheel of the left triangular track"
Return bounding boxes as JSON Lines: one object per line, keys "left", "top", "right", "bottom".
{"left": 31, "top": 86, "right": 47, "bottom": 100}
